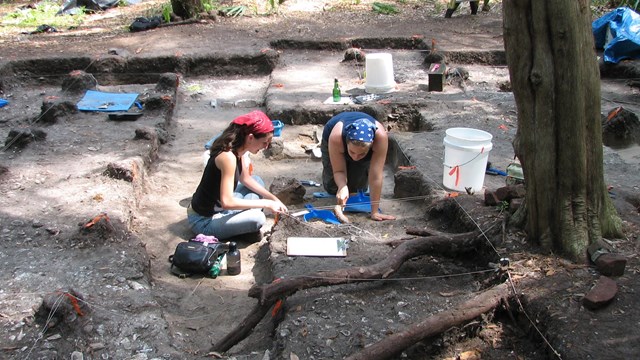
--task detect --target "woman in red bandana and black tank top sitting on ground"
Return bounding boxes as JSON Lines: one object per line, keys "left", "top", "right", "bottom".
{"left": 187, "top": 110, "right": 287, "bottom": 240}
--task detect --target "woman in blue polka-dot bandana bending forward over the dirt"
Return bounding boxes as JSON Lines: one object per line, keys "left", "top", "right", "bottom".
{"left": 320, "top": 111, "right": 395, "bottom": 221}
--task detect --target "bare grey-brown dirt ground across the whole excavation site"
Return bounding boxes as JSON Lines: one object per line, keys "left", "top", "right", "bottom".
{"left": 0, "top": 0, "right": 640, "bottom": 359}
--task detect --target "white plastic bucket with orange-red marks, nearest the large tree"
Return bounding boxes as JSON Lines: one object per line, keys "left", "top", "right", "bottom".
{"left": 442, "top": 128, "right": 493, "bottom": 192}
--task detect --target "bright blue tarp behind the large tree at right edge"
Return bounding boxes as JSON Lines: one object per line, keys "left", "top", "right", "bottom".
{"left": 591, "top": 7, "right": 640, "bottom": 64}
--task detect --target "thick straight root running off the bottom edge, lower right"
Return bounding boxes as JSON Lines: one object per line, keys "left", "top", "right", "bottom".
{"left": 346, "top": 283, "right": 511, "bottom": 360}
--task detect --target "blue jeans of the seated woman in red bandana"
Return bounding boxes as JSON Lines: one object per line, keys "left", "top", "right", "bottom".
{"left": 187, "top": 175, "right": 267, "bottom": 240}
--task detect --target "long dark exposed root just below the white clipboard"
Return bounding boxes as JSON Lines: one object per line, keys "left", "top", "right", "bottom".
{"left": 249, "top": 226, "right": 498, "bottom": 304}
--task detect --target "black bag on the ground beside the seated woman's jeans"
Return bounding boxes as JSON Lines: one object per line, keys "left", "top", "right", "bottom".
{"left": 169, "top": 241, "right": 229, "bottom": 277}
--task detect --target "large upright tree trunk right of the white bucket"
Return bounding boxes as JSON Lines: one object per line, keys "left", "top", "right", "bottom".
{"left": 503, "top": 0, "right": 621, "bottom": 262}
